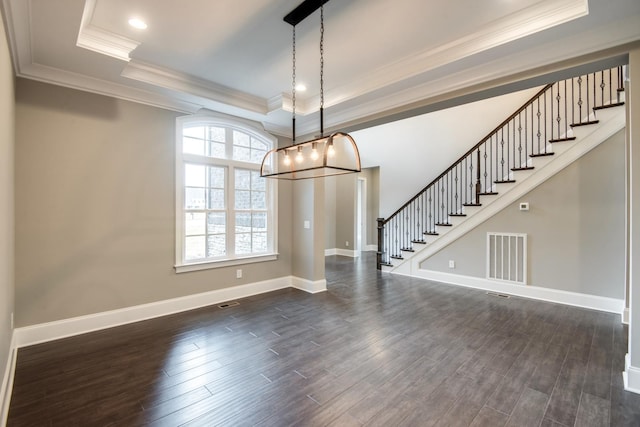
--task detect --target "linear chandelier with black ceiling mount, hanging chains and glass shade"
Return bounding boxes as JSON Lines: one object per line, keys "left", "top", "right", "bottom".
{"left": 260, "top": 0, "right": 360, "bottom": 180}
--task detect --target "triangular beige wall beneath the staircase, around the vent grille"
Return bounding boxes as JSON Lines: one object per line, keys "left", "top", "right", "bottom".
{"left": 421, "top": 130, "right": 625, "bottom": 299}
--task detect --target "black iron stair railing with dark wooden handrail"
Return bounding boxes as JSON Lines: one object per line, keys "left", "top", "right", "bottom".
{"left": 377, "top": 67, "right": 624, "bottom": 269}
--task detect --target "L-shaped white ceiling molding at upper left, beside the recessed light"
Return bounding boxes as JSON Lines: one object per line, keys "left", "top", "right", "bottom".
{"left": 76, "top": 0, "right": 140, "bottom": 62}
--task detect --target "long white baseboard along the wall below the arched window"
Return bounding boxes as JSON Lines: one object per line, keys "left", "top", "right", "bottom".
{"left": 14, "top": 276, "right": 298, "bottom": 347}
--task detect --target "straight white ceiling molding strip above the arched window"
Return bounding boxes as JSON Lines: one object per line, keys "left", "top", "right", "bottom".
{"left": 121, "top": 60, "right": 268, "bottom": 114}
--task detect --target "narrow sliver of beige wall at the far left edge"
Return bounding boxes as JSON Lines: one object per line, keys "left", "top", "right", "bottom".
{"left": 0, "top": 13, "right": 14, "bottom": 386}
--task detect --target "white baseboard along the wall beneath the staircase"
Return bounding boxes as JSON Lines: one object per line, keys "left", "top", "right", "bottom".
{"left": 404, "top": 269, "right": 624, "bottom": 314}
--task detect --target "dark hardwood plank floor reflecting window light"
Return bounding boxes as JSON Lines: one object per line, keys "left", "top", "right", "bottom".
{"left": 8, "top": 254, "right": 640, "bottom": 427}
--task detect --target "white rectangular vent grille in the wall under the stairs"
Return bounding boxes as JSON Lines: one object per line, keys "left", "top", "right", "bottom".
{"left": 487, "top": 232, "right": 527, "bottom": 285}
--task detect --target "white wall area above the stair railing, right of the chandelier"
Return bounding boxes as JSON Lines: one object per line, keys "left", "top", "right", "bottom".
{"left": 351, "top": 88, "right": 540, "bottom": 218}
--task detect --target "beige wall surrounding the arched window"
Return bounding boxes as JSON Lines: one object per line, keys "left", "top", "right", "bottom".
{"left": 15, "top": 79, "right": 292, "bottom": 326}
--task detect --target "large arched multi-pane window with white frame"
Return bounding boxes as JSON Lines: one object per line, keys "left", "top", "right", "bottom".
{"left": 176, "top": 114, "right": 277, "bottom": 272}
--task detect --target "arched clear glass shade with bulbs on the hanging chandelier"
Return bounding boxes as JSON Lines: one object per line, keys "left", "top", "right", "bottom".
{"left": 260, "top": 132, "right": 360, "bottom": 180}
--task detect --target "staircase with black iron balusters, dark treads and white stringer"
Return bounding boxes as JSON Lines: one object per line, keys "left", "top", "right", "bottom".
{"left": 377, "top": 67, "right": 625, "bottom": 275}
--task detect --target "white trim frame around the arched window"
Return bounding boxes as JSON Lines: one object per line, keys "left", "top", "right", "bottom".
{"left": 174, "top": 111, "right": 279, "bottom": 273}
